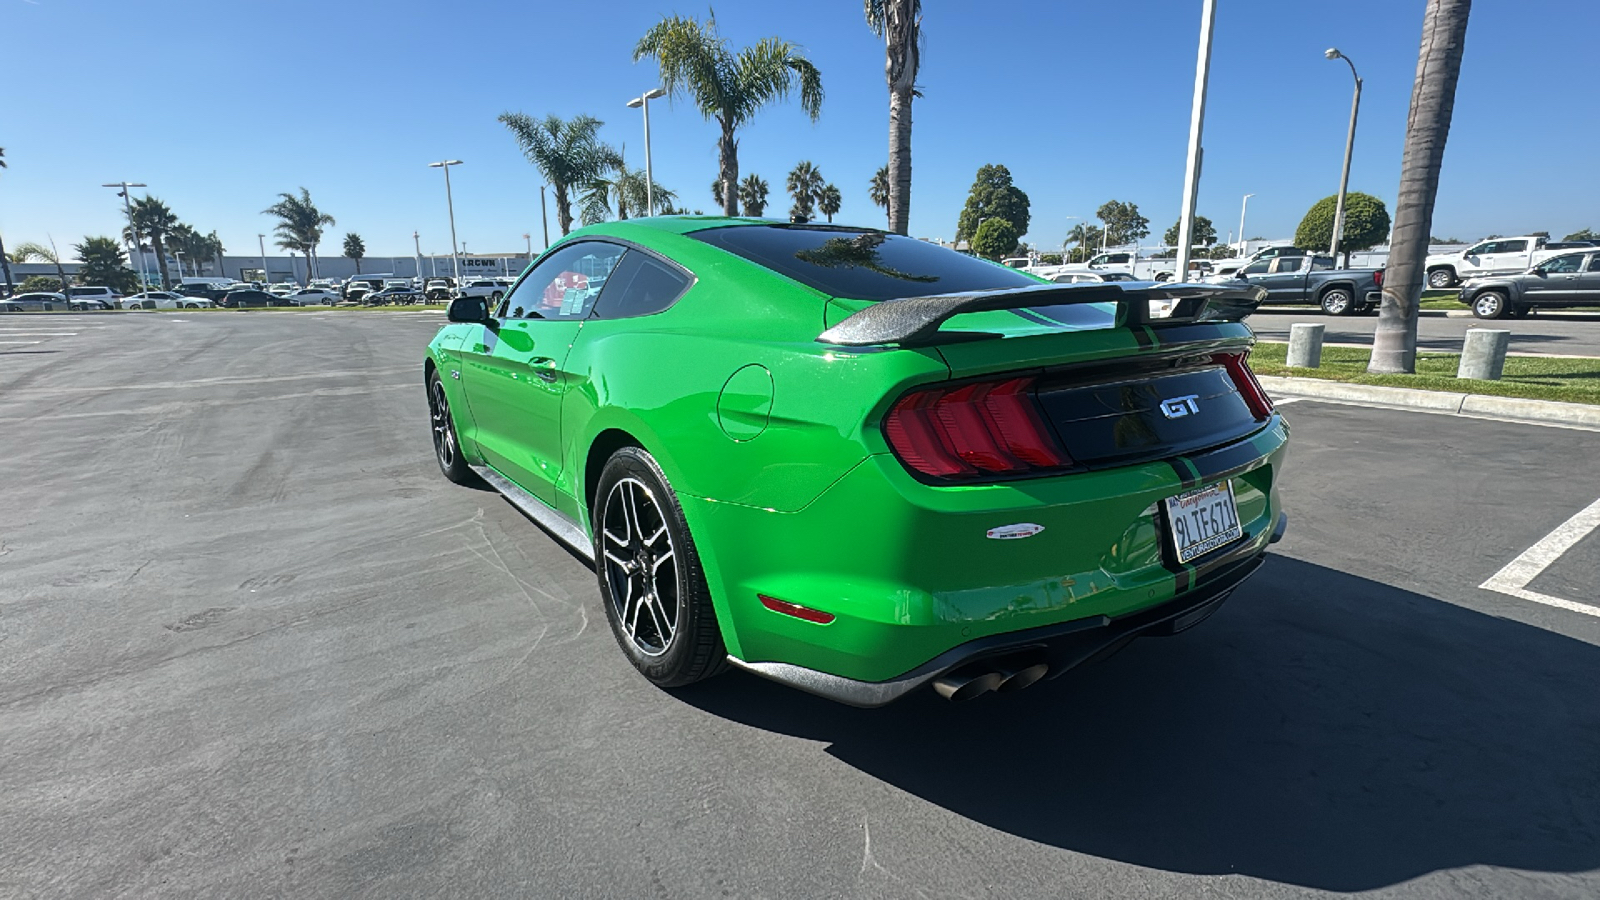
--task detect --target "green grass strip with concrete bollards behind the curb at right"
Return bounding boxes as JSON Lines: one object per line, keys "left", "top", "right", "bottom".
{"left": 1250, "top": 341, "right": 1600, "bottom": 405}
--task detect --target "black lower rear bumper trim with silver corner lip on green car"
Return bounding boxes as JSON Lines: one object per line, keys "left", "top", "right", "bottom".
{"left": 728, "top": 514, "right": 1288, "bottom": 708}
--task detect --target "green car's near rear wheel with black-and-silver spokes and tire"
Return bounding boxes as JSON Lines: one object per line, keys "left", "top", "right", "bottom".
{"left": 590, "top": 447, "right": 726, "bottom": 687}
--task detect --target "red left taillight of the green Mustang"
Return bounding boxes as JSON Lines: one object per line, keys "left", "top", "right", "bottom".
{"left": 883, "top": 378, "right": 1072, "bottom": 479}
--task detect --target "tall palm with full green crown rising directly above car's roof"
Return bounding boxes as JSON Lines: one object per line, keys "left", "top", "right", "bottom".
{"left": 634, "top": 16, "right": 822, "bottom": 216}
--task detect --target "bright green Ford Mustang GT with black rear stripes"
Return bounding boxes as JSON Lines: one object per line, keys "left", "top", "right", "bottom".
{"left": 424, "top": 216, "right": 1288, "bottom": 706}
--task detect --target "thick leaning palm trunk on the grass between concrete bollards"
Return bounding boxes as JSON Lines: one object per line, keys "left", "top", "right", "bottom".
{"left": 1366, "top": 0, "right": 1472, "bottom": 375}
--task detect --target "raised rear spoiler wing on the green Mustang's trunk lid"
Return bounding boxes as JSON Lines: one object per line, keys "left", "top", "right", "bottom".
{"left": 816, "top": 283, "right": 1267, "bottom": 348}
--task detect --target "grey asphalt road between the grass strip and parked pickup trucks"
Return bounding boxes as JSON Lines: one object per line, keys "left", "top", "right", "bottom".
{"left": 1248, "top": 306, "right": 1600, "bottom": 357}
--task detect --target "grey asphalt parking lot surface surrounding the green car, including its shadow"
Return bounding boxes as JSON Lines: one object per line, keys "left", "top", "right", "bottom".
{"left": 0, "top": 311, "right": 1600, "bottom": 898}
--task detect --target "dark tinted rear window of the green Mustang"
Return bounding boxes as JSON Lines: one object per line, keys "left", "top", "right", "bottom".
{"left": 690, "top": 226, "right": 1038, "bottom": 301}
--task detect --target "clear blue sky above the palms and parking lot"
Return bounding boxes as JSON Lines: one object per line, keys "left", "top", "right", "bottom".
{"left": 0, "top": 0, "right": 1600, "bottom": 256}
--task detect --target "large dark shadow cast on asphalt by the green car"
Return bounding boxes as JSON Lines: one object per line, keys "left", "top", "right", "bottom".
{"left": 677, "top": 557, "right": 1600, "bottom": 892}
